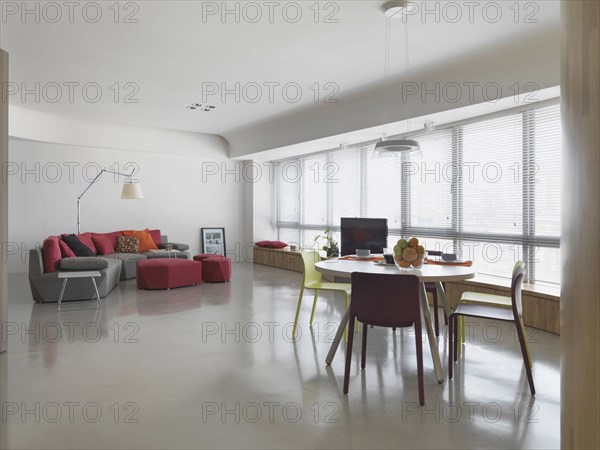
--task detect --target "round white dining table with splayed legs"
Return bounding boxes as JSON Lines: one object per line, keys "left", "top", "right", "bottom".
{"left": 315, "top": 259, "right": 476, "bottom": 383}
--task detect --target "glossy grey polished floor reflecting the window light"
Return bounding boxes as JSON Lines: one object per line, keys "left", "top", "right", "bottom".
{"left": 0, "top": 264, "right": 560, "bottom": 449}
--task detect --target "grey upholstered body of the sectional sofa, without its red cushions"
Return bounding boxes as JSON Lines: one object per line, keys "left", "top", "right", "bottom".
{"left": 29, "top": 235, "right": 190, "bottom": 303}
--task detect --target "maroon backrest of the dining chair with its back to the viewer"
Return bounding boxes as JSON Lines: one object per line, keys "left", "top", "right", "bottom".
{"left": 350, "top": 272, "right": 421, "bottom": 327}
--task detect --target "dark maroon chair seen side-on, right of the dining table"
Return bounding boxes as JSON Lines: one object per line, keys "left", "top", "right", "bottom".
{"left": 448, "top": 263, "right": 535, "bottom": 395}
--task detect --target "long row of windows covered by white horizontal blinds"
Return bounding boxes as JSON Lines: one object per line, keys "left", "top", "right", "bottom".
{"left": 277, "top": 101, "right": 561, "bottom": 283}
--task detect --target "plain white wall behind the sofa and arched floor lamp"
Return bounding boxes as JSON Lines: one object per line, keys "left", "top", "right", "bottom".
{"left": 7, "top": 137, "right": 248, "bottom": 273}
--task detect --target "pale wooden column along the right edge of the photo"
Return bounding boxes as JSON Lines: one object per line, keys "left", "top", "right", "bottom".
{"left": 560, "top": 0, "right": 600, "bottom": 449}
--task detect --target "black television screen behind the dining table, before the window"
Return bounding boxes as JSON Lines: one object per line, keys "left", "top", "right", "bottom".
{"left": 341, "top": 217, "right": 388, "bottom": 256}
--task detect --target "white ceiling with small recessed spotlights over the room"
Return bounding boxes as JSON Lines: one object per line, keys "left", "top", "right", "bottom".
{"left": 0, "top": 0, "right": 559, "bottom": 154}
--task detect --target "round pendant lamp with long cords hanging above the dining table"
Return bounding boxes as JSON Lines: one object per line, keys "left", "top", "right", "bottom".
{"left": 373, "top": 0, "right": 421, "bottom": 158}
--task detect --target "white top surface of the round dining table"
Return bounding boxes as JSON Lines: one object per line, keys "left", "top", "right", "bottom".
{"left": 315, "top": 259, "right": 477, "bottom": 283}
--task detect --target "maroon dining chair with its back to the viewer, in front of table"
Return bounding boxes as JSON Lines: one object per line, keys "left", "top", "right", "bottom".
{"left": 344, "top": 272, "right": 425, "bottom": 405}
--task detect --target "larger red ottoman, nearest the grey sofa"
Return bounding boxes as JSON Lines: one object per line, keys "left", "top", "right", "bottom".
{"left": 136, "top": 258, "right": 202, "bottom": 289}
